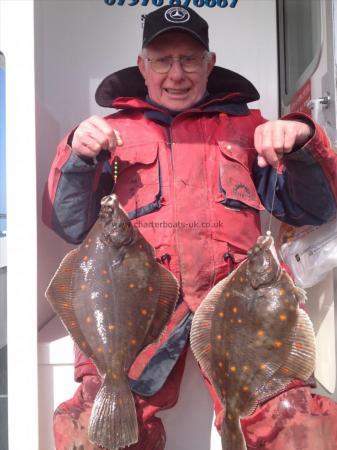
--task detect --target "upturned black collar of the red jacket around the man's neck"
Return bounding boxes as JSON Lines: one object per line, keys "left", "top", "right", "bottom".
{"left": 95, "top": 66, "right": 260, "bottom": 112}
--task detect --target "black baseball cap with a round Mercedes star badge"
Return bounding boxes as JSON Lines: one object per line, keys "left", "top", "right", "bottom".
{"left": 142, "top": 6, "right": 209, "bottom": 50}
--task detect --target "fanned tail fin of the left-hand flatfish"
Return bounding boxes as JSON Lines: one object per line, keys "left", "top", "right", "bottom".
{"left": 88, "top": 377, "right": 138, "bottom": 450}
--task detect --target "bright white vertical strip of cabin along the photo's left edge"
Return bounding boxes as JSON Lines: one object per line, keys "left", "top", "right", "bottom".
{"left": 0, "top": 0, "right": 38, "bottom": 450}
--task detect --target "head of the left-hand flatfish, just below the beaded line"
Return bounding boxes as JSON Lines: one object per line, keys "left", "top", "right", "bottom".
{"left": 99, "top": 194, "right": 135, "bottom": 248}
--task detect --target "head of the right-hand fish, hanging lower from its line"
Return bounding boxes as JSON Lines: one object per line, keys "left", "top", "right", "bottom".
{"left": 247, "top": 235, "right": 281, "bottom": 289}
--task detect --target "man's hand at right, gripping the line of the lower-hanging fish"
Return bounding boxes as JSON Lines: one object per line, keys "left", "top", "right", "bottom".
{"left": 254, "top": 120, "right": 311, "bottom": 167}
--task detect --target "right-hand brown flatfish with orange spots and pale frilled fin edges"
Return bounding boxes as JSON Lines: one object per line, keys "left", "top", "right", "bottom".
{"left": 191, "top": 235, "right": 315, "bottom": 450}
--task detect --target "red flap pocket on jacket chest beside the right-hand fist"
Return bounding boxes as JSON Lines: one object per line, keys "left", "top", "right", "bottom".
{"left": 217, "top": 141, "right": 264, "bottom": 210}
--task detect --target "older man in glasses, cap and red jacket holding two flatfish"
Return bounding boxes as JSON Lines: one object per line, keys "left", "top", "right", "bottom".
{"left": 44, "top": 6, "right": 337, "bottom": 450}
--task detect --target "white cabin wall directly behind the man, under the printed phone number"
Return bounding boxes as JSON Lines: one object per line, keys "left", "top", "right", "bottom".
{"left": 35, "top": 0, "right": 278, "bottom": 450}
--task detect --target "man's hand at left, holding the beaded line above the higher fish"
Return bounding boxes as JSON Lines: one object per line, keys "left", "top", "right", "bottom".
{"left": 71, "top": 116, "right": 123, "bottom": 158}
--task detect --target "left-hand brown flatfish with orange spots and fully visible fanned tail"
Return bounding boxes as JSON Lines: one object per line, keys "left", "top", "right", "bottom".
{"left": 46, "top": 194, "right": 179, "bottom": 450}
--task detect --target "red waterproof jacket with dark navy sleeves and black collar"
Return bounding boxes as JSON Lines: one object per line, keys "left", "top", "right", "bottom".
{"left": 44, "top": 67, "right": 337, "bottom": 395}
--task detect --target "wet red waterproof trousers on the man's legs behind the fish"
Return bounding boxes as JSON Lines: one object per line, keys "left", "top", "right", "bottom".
{"left": 54, "top": 344, "right": 337, "bottom": 450}
